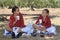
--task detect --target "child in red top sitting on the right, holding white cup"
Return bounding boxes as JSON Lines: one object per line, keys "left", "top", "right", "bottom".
{"left": 33, "top": 9, "right": 56, "bottom": 37}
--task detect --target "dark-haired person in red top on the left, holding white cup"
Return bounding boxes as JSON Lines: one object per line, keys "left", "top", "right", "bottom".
{"left": 5, "top": 6, "right": 25, "bottom": 38}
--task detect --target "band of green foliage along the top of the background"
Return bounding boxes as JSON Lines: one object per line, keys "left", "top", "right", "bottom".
{"left": 0, "top": 0, "right": 60, "bottom": 8}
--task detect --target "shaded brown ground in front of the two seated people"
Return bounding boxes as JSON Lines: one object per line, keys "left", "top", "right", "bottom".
{"left": 0, "top": 26, "right": 60, "bottom": 40}
